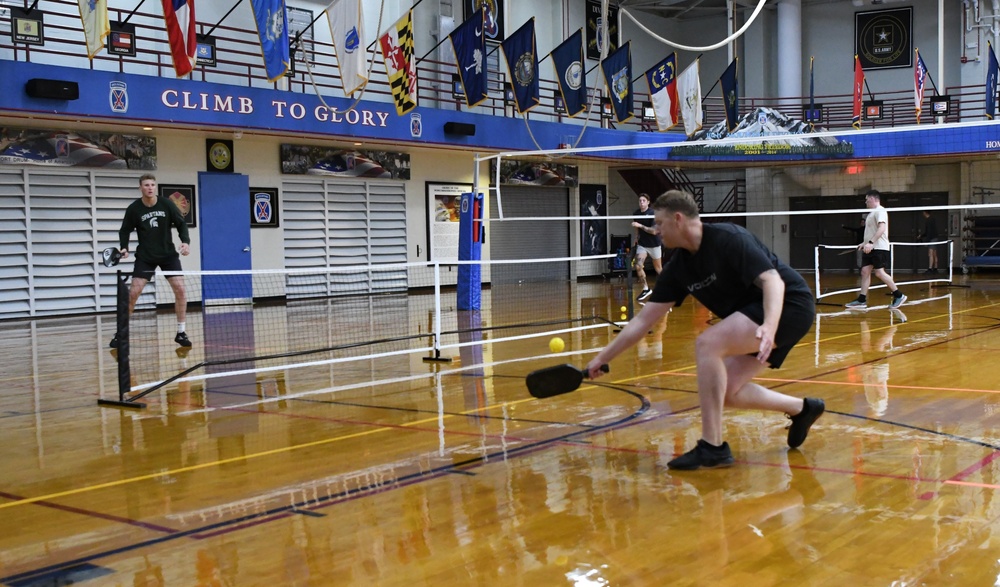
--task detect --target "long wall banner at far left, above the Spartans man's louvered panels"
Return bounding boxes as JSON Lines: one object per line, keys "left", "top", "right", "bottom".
{"left": 0, "top": 127, "right": 156, "bottom": 171}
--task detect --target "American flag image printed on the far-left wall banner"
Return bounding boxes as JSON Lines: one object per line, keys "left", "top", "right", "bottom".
{"left": 0, "top": 133, "right": 128, "bottom": 169}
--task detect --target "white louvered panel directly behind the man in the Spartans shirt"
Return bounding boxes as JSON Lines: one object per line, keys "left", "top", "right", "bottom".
{"left": 94, "top": 172, "right": 146, "bottom": 312}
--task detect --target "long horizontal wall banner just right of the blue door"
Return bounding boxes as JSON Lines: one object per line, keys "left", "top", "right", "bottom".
{"left": 281, "top": 144, "right": 410, "bottom": 179}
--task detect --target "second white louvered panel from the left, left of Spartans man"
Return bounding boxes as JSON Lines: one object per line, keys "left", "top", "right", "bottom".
{"left": 28, "top": 176, "right": 97, "bottom": 316}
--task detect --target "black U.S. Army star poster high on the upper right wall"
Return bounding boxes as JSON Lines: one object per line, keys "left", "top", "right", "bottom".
{"left": 854, "top": 6, "right": 913, "bottom": 71}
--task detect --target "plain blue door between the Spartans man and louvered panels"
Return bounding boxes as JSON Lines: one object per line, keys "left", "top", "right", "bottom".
{"left": 198, "top": 172, "right": 253, "bottom": 304}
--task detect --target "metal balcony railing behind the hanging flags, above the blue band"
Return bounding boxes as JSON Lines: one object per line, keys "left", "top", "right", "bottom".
{"left": 0, "top": 0, "right": 986, "bottom": 132}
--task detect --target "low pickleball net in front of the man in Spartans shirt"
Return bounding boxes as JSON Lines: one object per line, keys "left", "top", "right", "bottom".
{"left": 101, "top": 256, "right": 625, "bottom": 407}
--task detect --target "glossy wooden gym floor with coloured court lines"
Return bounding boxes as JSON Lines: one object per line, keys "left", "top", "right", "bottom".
{"left": 0, "top": 275, "right": 1000, "bottom": 587}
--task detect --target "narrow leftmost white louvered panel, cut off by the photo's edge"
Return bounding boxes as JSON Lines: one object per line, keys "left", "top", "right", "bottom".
{"left": 0, "top": 169, "right": 31, "bottom": 319}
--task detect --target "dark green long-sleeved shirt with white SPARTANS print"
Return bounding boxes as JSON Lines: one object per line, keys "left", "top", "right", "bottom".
{"left": 118, "top": 197, "right": 191, "bottom": 262}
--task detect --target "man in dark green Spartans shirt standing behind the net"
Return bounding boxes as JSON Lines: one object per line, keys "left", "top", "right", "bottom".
{"left": 111, "top": 173, "right": 191, "bottom": 348}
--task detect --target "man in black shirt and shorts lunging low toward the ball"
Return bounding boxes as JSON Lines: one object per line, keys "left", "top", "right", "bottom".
{"left": 587, "top": 190, "right": 825, "bottom": 469}
